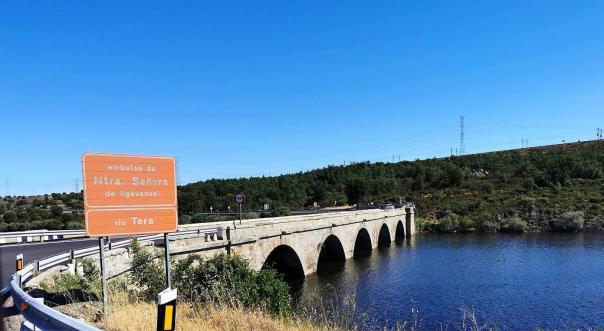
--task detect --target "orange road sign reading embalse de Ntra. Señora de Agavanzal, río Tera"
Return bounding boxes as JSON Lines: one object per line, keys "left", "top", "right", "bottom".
{"left": 82, "top": 153, "right": 178, "bottom": 237}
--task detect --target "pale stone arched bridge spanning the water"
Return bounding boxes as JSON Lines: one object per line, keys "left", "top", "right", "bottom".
{"left": 170, "top": 208, "right": 416, "bottom": 277}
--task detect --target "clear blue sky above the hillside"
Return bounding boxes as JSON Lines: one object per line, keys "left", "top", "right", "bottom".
{"left": 0, "top": 0, "right": 604, "bottom": 195}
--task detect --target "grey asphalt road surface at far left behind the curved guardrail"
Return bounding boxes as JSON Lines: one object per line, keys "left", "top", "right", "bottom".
{"left": 0, "top": 238, "right": 101, "bottom": 288}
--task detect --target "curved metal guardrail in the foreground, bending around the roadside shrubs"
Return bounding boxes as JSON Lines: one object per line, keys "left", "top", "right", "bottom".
{"left": 0, "top": 228, "right": 222, "bottom": 331}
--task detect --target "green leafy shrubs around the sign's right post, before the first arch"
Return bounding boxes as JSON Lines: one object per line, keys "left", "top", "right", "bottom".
{"left": 131, "top": 242, "right": 292, "bottom": 316}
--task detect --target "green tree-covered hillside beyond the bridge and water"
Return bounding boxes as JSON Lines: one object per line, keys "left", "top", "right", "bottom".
{"left": 0, "top": 141, "right": 604, "bottom": 231}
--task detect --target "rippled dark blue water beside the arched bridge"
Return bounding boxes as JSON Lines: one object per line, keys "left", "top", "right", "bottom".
{"left": 296, "top": 233, "right": 604, "bottom": 330}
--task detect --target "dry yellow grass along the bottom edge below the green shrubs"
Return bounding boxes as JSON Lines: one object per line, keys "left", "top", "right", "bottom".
{"left": 96, "top": 294, "right": 326, "bottom": 331}
